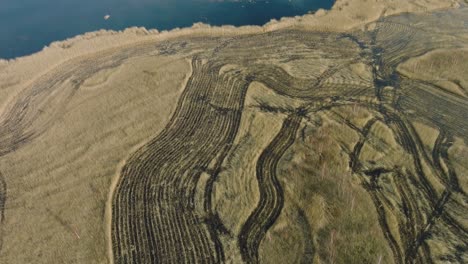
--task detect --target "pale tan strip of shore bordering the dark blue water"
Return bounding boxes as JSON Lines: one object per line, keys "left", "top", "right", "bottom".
{"left": 0, "top": 0, "right": 461, "bottom": 104}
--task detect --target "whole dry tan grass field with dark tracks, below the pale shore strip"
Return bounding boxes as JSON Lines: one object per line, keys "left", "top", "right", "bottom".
{"left": 0, "top": 1, "right": 468, "bottom": 264}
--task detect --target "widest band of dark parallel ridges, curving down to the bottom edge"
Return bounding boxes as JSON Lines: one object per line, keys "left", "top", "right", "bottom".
{"left": 112, "top": 58, "right": 252, "bottom": 263}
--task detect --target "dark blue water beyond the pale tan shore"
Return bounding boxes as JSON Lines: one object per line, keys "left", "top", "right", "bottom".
{"left": 0, "top": 0, "right": 334, "bottom": 59}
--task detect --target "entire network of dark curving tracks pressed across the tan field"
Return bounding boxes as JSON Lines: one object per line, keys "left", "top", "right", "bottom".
{"left": 0, "top": 6, "right": 468, "bottom": 263}
